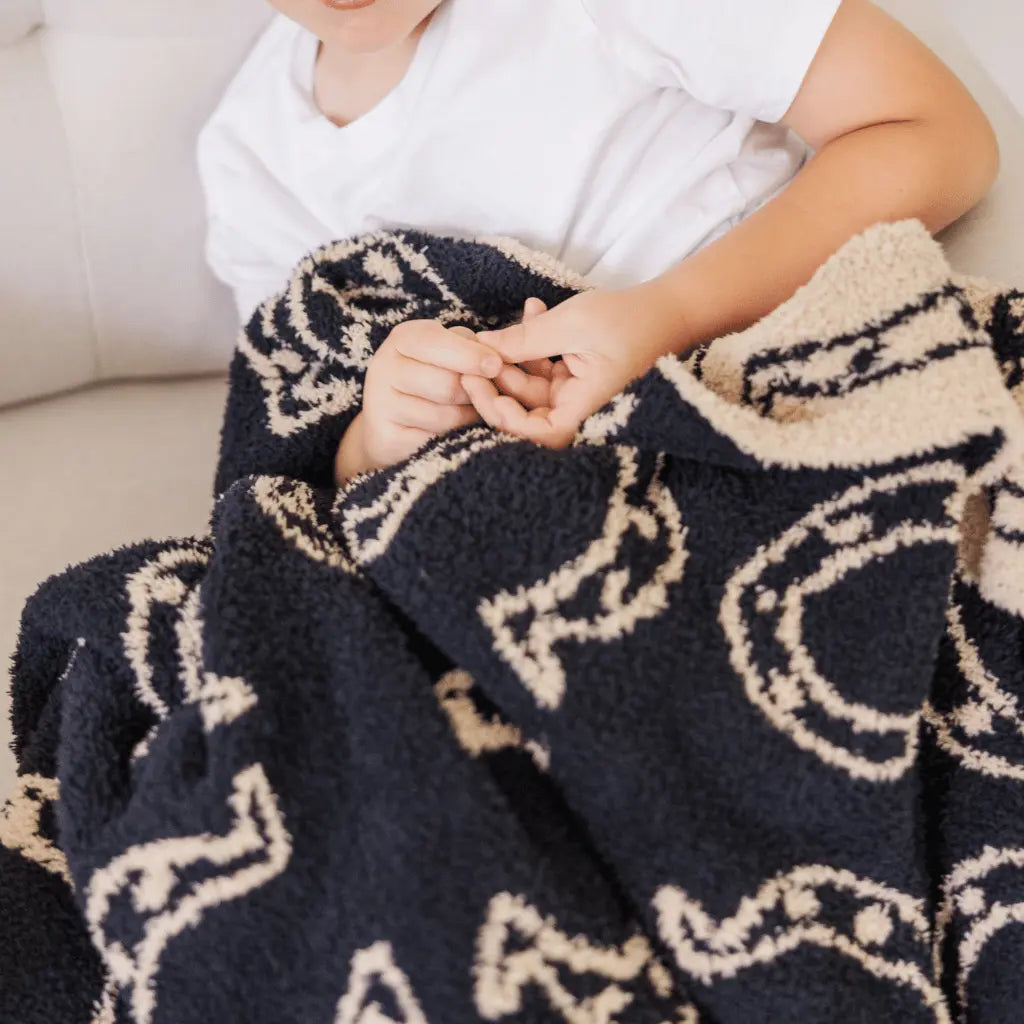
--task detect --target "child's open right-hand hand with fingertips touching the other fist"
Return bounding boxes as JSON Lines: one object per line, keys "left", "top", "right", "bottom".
{"left": 462, "top": 285, "right": 685, "bottom": 447}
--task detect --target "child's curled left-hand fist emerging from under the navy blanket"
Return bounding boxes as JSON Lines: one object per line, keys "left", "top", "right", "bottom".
{"left": 335, "top": 321, "right": 502, "bottom": 485}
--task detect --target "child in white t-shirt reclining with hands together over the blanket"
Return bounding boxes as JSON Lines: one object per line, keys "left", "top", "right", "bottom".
{"left": 199, "top": 0, "right": 998, "bottom": 483}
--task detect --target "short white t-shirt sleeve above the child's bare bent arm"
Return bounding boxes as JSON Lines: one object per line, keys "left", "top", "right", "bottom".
{"left": 582, "top": 0, "right": 841, "bottom": 122}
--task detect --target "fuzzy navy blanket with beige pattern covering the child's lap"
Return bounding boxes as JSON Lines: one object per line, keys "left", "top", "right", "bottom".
{"left": 0, "top": 221, "right": 1024, "bottom": 1024}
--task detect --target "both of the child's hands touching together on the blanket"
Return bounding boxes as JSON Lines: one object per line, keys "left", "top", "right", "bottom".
{"left": 335, "top": 286, "right": 678, "bottom": 483}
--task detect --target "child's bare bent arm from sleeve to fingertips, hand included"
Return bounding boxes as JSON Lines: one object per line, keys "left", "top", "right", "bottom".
{"left": 467, "top": 0, "right": 998, "bottom": 444}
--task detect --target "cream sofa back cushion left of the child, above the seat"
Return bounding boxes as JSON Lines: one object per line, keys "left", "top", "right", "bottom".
{"left": 0, "top": 0, "right": 271, "bottom": 404}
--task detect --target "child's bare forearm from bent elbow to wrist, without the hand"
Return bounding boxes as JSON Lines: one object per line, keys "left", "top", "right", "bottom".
{"left": 640, "top": 119, "right": 998, "bottom": 351}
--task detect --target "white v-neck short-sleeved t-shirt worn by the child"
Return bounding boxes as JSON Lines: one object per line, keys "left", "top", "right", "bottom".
{"left": 199, "top": 0, "right": 840, "bottom": 319}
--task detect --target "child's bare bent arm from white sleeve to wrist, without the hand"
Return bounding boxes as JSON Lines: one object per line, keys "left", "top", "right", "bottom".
{"left": 643, "top": 0, "right": 999, "bottom": 347}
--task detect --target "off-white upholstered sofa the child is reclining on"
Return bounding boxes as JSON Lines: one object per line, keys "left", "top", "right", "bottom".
{"left": 0, "top": 0, "right": 1024, "bottom": 792}
